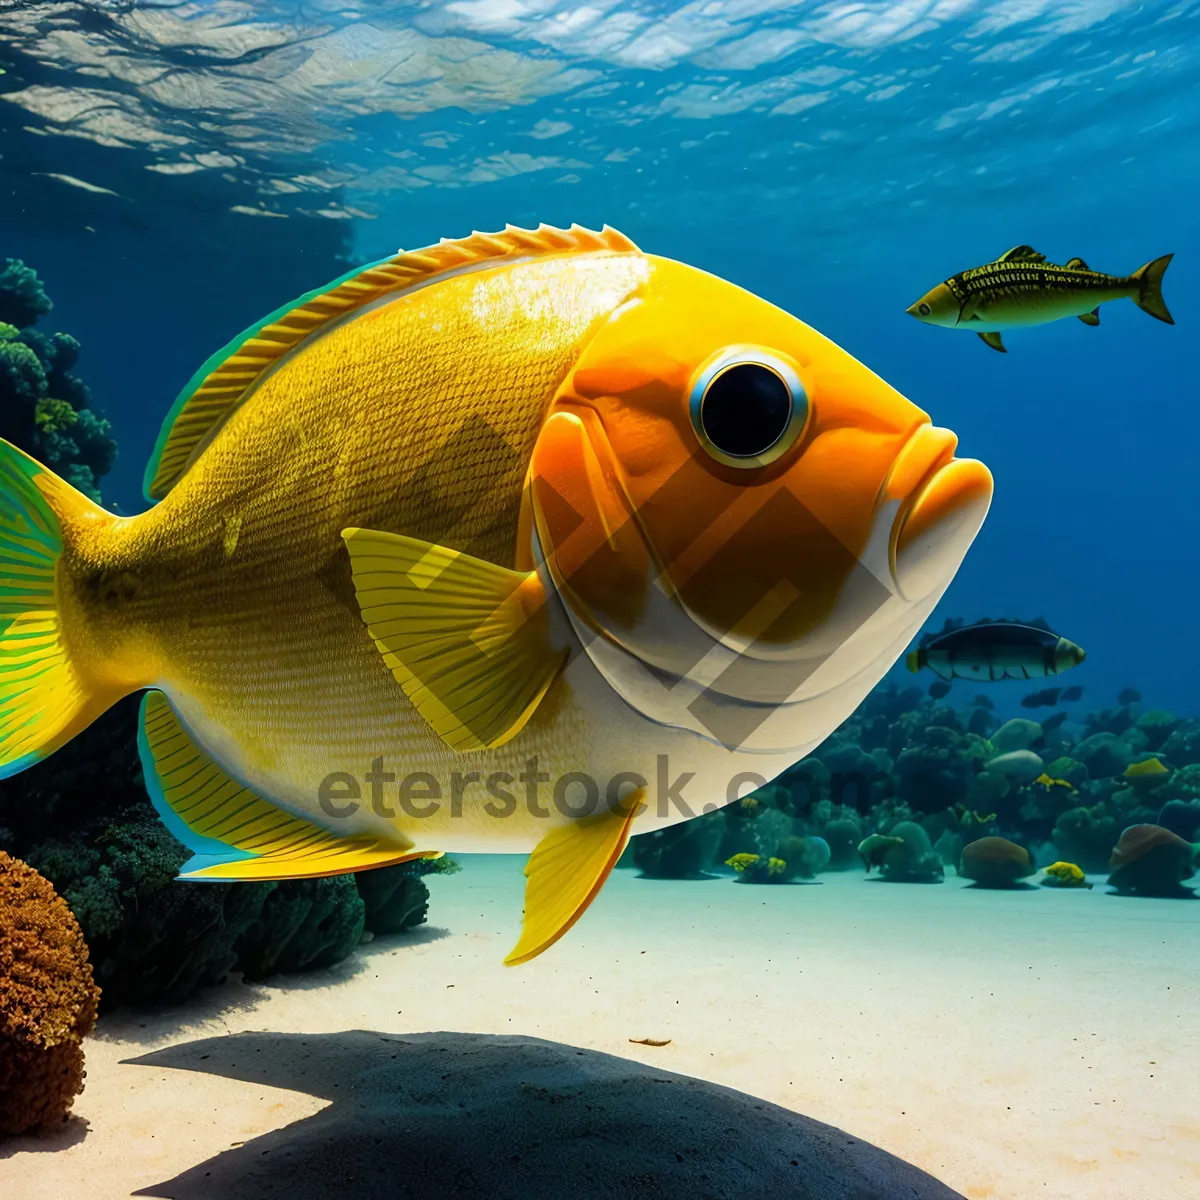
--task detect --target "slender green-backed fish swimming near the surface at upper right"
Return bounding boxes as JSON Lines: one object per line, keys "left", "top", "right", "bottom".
{"left": 905, "top": 246, "right": 1175, "bottom": 353}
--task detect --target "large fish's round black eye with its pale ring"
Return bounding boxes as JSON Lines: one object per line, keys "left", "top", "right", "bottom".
{"left": 689, "top": 346, "right": 810, "bottom": 469}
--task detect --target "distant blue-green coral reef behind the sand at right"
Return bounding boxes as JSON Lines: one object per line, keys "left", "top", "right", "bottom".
{"left": 623, "top": 682, "right": 1200, "bottom": 882}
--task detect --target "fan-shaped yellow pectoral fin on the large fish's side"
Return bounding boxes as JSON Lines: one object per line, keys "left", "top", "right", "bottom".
{"left": 342, "top": 529, "right": 568, "bottom": 750}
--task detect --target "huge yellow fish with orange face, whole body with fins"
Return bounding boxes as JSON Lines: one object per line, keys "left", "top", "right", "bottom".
{"left": 0, "top": 226, "right": 992, "bottom": 964}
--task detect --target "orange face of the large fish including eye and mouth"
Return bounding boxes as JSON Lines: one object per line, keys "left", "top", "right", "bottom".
{"left": 532, "top": 258, "right": 991, "bottom": 691}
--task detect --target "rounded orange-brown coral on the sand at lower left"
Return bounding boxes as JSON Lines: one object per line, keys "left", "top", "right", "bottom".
{"left": 0, "top": 851, "right": 100, "bottom": 1134}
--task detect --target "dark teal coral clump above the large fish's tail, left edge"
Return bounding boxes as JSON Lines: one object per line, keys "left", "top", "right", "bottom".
{"left": 0, "top": 258, "right": 116, "bottom": 504}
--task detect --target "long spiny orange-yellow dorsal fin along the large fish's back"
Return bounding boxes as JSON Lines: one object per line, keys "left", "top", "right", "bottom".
{"left": 144, "top": 224, "right": 640, "bottom": 500}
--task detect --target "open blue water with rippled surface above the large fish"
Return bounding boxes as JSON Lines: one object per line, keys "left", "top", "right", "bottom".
{"left": 0, "top": 0, "right": 1200, "bottom": 712}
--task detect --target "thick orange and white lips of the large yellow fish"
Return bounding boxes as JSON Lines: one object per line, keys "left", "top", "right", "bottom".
{"left": 884, "top": 425, "right": 992, "bottom": 601}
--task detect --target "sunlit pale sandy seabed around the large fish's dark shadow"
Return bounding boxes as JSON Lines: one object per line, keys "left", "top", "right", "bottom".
{"left": 0, "top": 857, "right": 1200, "bottom": 1200}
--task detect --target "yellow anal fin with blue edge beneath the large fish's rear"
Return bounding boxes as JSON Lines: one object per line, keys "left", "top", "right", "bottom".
{"left": 138, "top": 691, "right": 440, "bottom": 882}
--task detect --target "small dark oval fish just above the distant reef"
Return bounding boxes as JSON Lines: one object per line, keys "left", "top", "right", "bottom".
{"left": 905, "top": 620, "right": 1086, "bottom": 683}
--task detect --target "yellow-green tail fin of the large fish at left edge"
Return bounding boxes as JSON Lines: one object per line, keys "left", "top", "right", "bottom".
{"left": 0, "top": 438, "right": 115, "bottom": 779}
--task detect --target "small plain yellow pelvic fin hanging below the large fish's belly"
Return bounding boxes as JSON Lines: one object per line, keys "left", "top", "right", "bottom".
{"left": 504, "top": 788, "right": 646, "bottom": 967}
